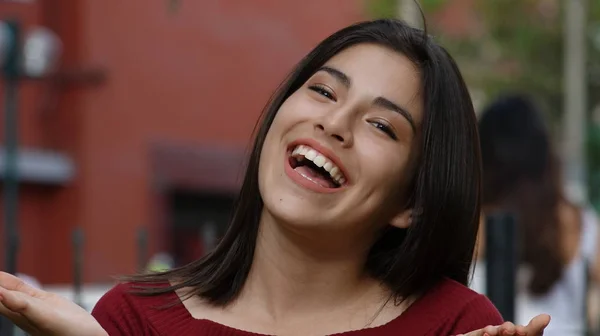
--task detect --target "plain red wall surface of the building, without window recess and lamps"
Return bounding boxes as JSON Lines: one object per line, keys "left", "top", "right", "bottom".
{"left": 0, "top": 0, "right": 363, "bottom": 283}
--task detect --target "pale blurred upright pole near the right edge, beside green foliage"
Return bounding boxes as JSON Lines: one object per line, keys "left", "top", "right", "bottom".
{"left": 562, "top": 0, "right": 588, "bottom": 203}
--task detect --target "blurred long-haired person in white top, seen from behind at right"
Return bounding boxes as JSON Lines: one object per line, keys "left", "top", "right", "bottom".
{"left": 478, "top": 95, "right": 600, "bottom": 336}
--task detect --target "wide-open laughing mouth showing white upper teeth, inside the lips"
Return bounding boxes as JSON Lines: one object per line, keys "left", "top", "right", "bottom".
{"left": 289, "top": 145, "right": 347, "bottom": 189}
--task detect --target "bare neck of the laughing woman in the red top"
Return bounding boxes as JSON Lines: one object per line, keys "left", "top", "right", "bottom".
{"left": 235, "top": 213, "right": 387, "bottom": 322}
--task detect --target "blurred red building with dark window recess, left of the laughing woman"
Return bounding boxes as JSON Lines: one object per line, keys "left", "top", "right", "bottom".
{"left": 0, "top": 0, "right": 364, "bottom": 284}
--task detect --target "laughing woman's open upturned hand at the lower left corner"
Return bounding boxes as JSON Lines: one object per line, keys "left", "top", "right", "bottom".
{"left": 0, "top": 272, "right": 108, "bottom": 336}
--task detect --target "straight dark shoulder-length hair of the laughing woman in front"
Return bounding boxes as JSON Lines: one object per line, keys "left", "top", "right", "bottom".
{"left": 125, "top": 19, "right": 481, "bottom": 305}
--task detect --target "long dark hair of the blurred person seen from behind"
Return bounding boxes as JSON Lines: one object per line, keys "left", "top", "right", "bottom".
{"left": 479, "top": 94, "right": 564, "bottom": 295}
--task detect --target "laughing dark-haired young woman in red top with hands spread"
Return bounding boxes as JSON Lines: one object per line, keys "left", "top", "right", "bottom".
{"left": 0, "top": 20, "right": 549, "bottom": 336}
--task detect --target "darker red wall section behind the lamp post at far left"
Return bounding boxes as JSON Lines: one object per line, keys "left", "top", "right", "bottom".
{"left": 0, "top": 0, "right": 88, "bottom": 282}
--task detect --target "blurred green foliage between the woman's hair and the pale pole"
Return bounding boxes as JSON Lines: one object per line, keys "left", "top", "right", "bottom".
{"left": 438, "top": 0, "right": 562, "bottom": 122}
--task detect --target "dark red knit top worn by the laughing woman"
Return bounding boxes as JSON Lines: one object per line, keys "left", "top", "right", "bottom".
{"left": 92, "top": 280, "right": 503, "bottom": 336}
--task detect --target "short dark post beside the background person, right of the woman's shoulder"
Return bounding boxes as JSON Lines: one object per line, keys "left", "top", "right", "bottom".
{"left": 485, "top": 213, "right": 518, "bottom": 321}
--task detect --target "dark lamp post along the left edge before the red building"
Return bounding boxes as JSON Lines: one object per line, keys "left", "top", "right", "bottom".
{"left": 1, "top": 21, "right": 21, "bottom": 336}
